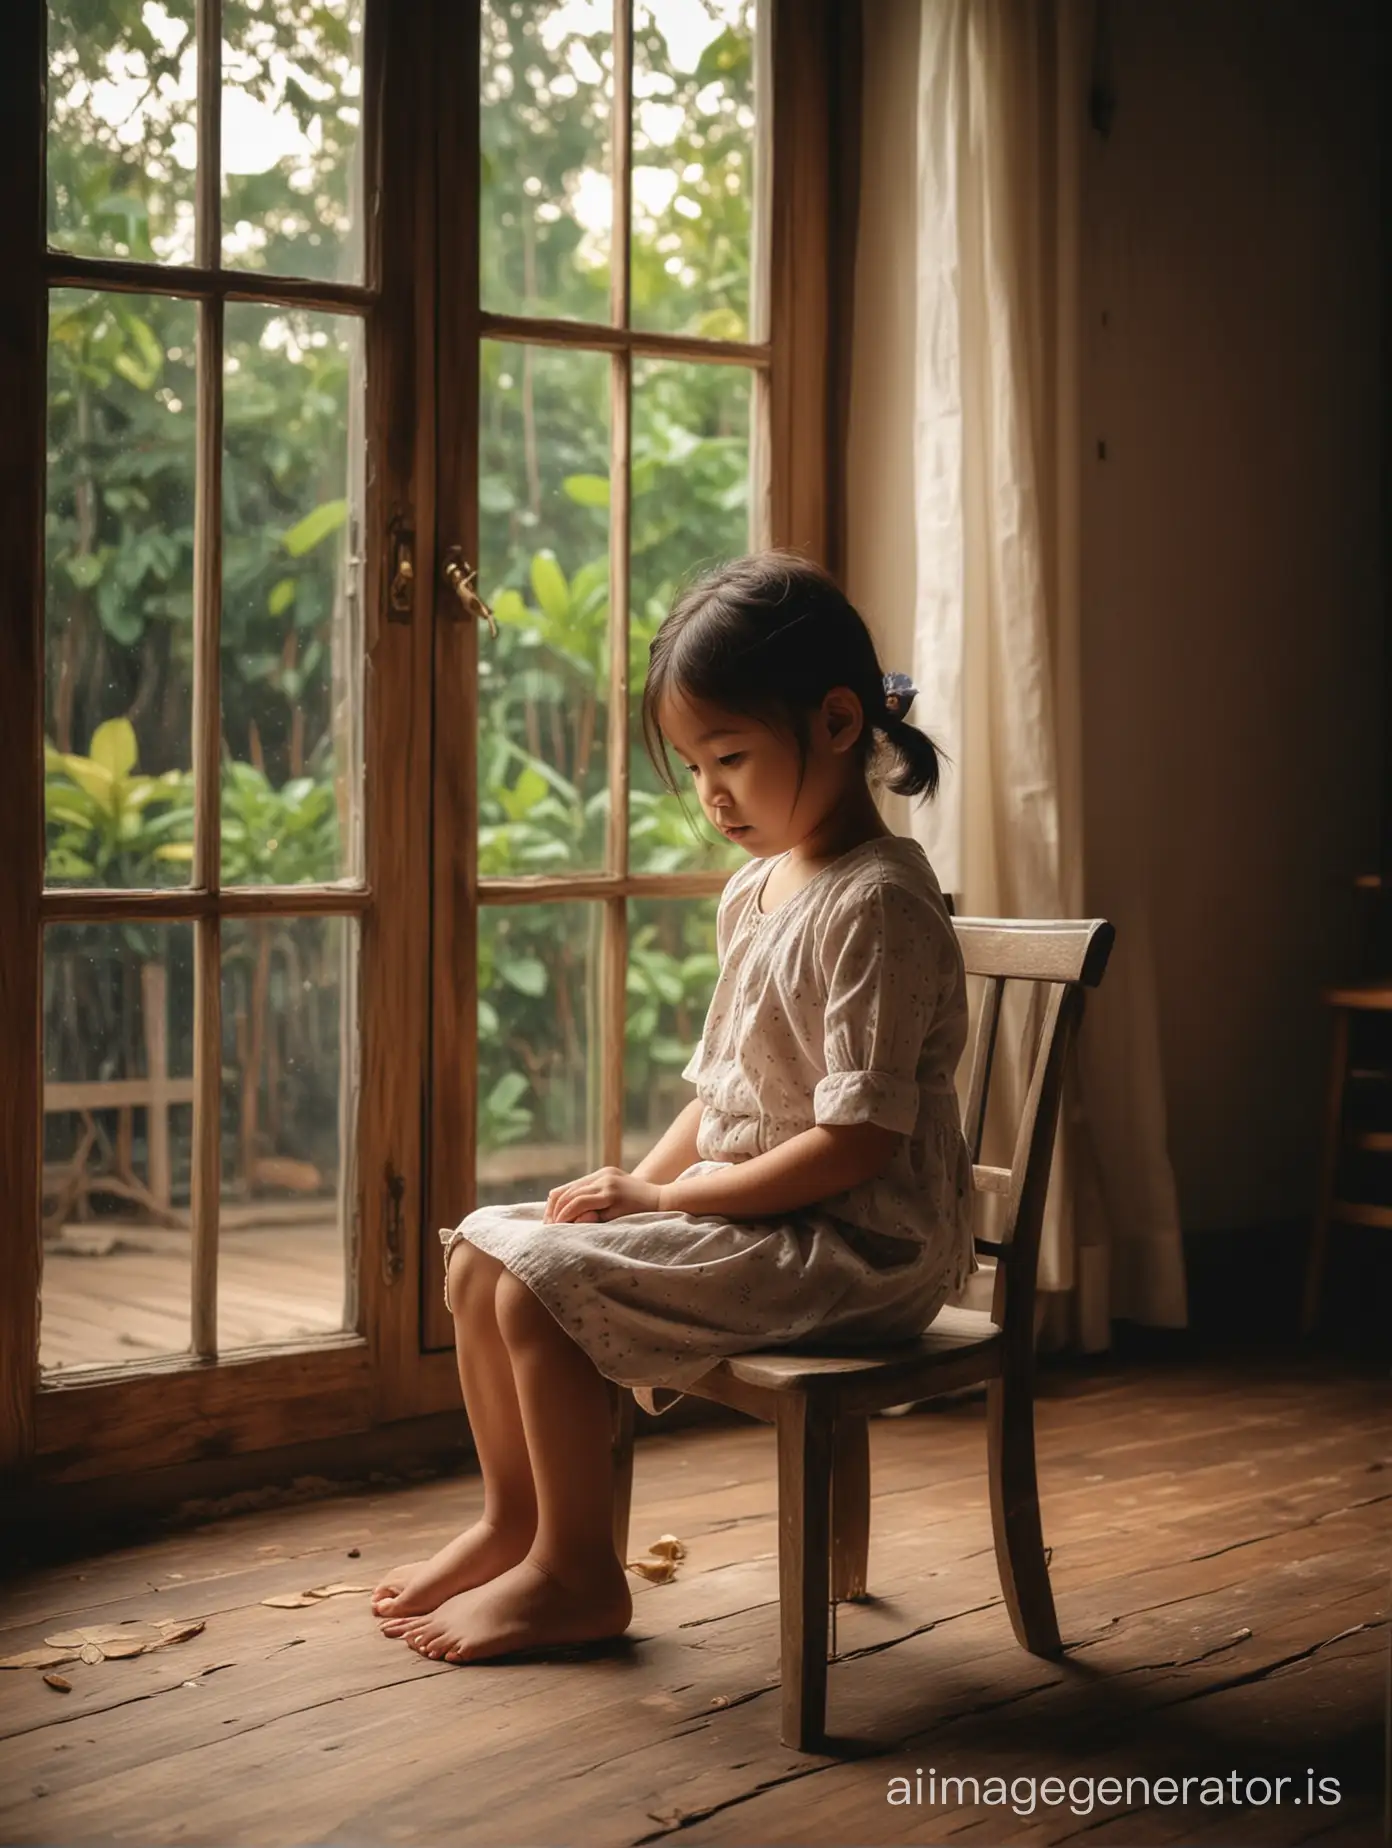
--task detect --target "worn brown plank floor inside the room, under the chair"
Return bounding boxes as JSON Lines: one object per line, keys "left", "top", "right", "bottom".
{"left": 0, "top": 1360, "right": 1392, "bottom": 1848}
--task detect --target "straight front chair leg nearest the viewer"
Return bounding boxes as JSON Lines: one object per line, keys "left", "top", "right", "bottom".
{"left": 776, "top": 1393, "right": 832, "bottom": 1752}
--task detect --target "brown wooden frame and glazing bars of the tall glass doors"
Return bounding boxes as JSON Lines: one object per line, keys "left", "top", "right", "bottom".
{"left": 0, "top": 0, "right": 858, "bottom": 1488}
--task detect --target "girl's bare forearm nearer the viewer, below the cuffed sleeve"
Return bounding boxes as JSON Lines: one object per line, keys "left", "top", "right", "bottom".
{"left": 658, "top": 1112, "right": 900, "bottom": 1220}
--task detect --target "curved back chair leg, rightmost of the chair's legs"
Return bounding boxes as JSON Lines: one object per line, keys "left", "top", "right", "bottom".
{"left": 985, "top": 1377, "right": 1063, "bottom": 1656}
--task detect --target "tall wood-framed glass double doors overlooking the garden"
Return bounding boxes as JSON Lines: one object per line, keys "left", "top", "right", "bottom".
{"left": 0, "top": 0, "right": 836, "bottom": 1478}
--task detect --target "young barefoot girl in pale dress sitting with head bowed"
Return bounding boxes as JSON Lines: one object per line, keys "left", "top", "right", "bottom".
{"left": 373, "top": 553, "right": 976, "bottom": 1661}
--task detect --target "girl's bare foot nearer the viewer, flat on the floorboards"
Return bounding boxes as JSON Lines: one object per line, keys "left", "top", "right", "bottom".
{"left": 405, "top": 1554, "right": 632, "bottom": 1661}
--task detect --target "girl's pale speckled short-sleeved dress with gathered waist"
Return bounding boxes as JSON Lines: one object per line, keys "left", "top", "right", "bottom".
{"left": 440, "top": 835, "right": 976, "bottom": 1408}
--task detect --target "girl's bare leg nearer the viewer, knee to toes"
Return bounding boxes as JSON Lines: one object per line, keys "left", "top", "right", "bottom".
{"left": 405, "top": 1271, "right": 632, "bottom": 1661}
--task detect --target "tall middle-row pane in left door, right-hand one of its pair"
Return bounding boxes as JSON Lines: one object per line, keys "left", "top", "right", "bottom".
{"left": 222, "top": 303, "right": 362, "bottom": 885}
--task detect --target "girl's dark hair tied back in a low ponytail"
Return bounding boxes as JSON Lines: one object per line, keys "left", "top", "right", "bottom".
{"left": 643, "top": 553, "right": 939, "bottom": 798}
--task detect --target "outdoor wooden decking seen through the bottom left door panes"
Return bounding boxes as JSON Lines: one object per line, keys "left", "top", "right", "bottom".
{"left": 39, "top": 1201, "right": 344, "bottom": 1373}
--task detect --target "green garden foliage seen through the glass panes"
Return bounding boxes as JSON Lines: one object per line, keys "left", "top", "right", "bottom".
{"left": 46, "top": 0, "right": 752, "bottom": 1194}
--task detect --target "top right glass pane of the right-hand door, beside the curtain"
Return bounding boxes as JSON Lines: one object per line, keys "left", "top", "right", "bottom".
{"left": 632, "top": 0, "right": 762, "bottom": 340}
